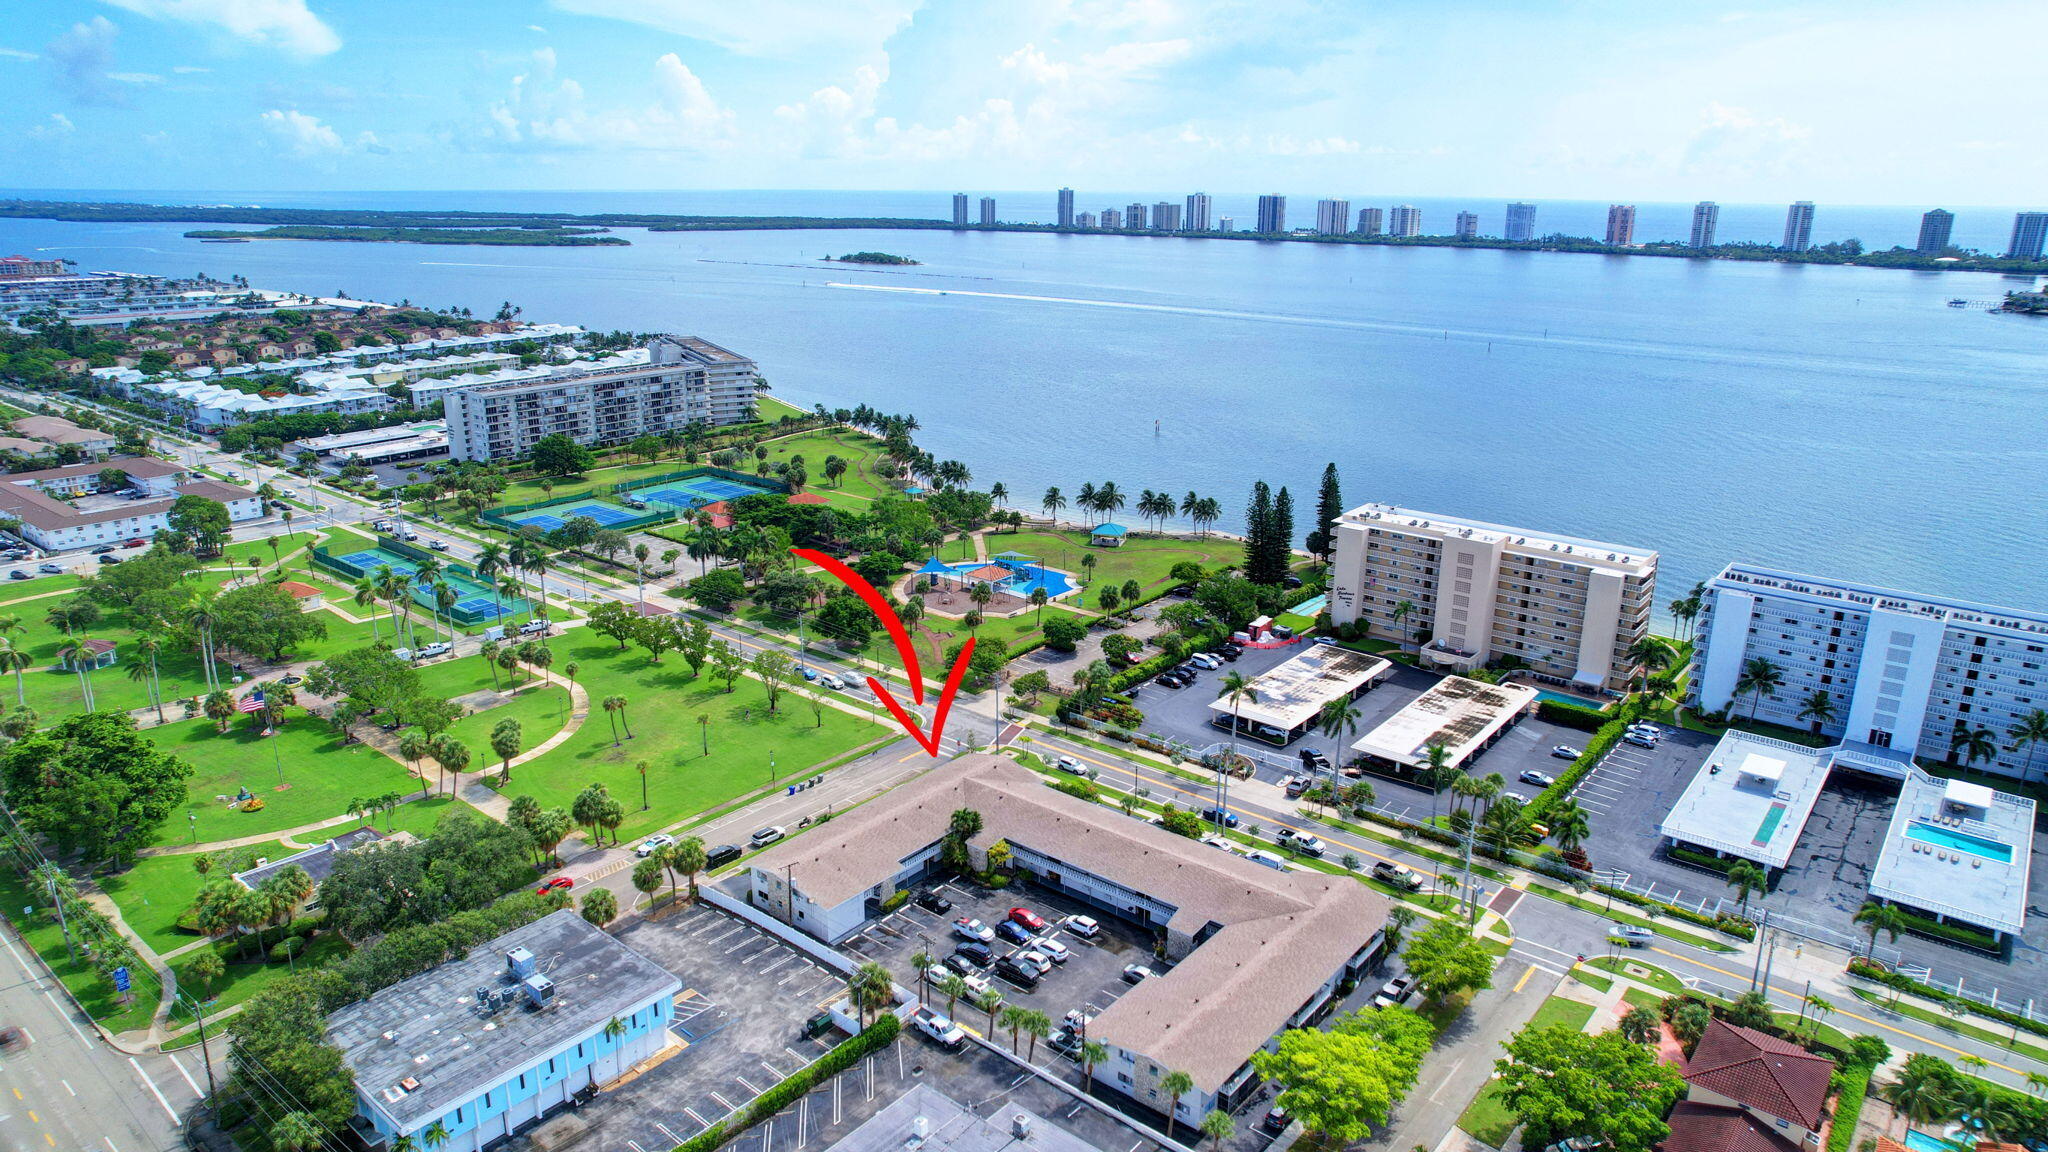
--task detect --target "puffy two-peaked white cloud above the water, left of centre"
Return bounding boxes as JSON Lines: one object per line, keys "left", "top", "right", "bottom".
{"left": 487, "top": 47, "right": 733, "bottom": 152}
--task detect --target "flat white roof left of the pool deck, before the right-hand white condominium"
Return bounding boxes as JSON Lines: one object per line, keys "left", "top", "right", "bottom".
{"left": 1657, "top": 730, "right": 1831, "bottom": 867}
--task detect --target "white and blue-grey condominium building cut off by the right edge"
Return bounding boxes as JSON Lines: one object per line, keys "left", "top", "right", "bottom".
{"left": 1692, "top": 564, "right": 2048, "bottom": 779}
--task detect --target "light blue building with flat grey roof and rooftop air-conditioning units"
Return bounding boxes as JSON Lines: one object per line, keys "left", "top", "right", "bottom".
{"left": 328, "top": 908, "right": 682, "bottom": 1152}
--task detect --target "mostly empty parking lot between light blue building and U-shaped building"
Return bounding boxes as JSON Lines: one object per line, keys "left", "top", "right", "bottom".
{"left": 586, "top": 904, "right": 846, "bottom": 1152}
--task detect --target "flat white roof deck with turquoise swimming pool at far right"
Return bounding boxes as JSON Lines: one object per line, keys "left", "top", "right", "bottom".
{"left": 1870, "top": 769, "right": 2034, "bottom": 933}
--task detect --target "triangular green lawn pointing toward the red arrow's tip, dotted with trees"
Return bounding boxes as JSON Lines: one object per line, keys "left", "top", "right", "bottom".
{"left": 506, "top": 629, "right": 885, "bottom": 838}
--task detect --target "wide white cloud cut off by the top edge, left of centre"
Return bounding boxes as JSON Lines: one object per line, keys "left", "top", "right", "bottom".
{"left": 555, "top": 0, "right": 922, "bottom": 59}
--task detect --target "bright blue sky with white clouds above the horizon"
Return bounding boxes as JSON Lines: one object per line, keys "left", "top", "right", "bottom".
{"left": 0, "top": 0, "right": 2048, "bottom": 205}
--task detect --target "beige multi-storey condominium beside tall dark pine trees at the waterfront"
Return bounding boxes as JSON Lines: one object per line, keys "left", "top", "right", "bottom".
{"left": 1329, "top": 504, "right": 1657, "bottom": 691}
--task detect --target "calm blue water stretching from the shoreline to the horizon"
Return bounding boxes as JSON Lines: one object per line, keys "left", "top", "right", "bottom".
{"left": 0, "top": 193, "right": 2048, "bottom": 619}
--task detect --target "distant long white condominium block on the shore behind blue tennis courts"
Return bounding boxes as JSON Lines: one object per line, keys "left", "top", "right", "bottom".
{"left": 444, "top": 336, "right": 760, "bottom": 459}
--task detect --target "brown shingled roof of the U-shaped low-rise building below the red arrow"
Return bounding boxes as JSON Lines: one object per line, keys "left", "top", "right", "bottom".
{"left": 752, "top": 754, "right": 1389, "bottom": 1093}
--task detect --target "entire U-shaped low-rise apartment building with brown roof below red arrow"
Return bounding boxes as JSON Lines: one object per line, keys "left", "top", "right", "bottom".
{"left": 748, "top": 754, "right": 1389, "bottom": 1125}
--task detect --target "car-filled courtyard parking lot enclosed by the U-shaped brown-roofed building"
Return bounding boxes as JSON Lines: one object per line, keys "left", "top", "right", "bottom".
{"left": 840, "top": 879, "right": 1165, "bottom": 1039}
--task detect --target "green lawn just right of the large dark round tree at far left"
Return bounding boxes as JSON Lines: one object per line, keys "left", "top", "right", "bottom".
{"left": 163, "top": 715, "right": 418, "bottom": 845}
